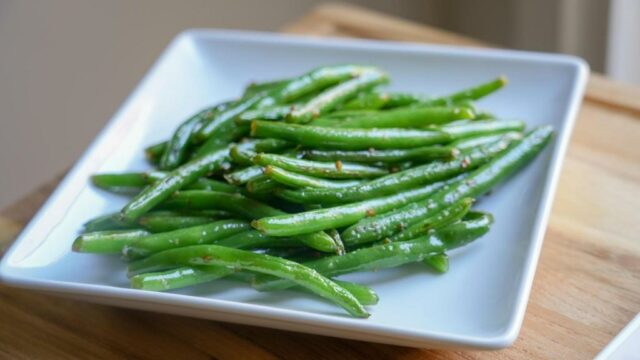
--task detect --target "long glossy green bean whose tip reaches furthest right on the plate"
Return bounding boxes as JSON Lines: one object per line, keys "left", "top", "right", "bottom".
{"left": 341, "top": 126, "right": 553, "bottom": 244}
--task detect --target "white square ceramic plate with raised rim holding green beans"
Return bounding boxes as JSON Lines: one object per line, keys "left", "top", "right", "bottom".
{"left": 0, "top": 30, "right": 588, "bottom": 348}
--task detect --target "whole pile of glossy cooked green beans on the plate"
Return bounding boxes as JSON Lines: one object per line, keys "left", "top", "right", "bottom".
{"left": 72, "top": 64, "right": 553, "bottom": 318}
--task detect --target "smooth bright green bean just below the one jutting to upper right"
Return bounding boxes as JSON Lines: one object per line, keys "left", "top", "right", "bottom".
{"left": 312, "top": 107, "right": 475, "bottom": 129}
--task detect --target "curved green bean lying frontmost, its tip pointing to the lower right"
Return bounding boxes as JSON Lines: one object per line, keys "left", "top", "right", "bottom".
{"left": 133, "top": 245, "right": 369, "bottom": 317}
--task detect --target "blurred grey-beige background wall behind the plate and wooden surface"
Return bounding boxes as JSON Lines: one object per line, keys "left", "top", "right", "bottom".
{"left": 0, "top": 0, "right": 640, "bottom": 206}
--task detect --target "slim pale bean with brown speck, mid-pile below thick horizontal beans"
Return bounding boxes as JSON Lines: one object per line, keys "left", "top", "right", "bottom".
{"left": 253, "top": 153, "right": 387, "bottom": 179}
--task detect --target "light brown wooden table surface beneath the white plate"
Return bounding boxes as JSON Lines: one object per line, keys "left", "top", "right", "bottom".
{"left": 0, "top": 4, "right": 640, "bottom": 359}
